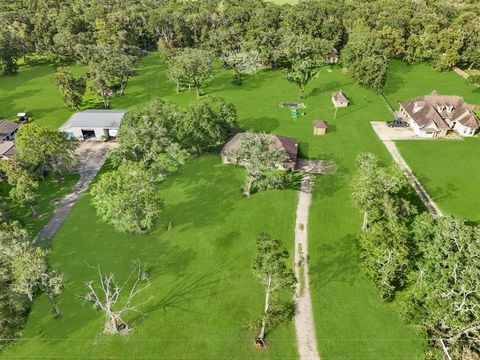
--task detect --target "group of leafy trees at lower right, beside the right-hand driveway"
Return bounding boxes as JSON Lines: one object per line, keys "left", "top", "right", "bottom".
{"left": 352, "top": 154, "right": 480, "bottom": 359}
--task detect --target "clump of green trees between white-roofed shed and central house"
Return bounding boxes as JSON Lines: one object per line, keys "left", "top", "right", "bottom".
{"left": 91, "top": 96, "right": 238, "bottom": 234}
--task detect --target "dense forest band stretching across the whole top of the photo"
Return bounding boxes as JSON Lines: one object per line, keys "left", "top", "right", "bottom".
{"left": 0, "top": 0, "right": 480, "bottom": 93}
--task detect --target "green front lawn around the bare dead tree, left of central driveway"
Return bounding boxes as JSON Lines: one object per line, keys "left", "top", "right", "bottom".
{"left": 3, "top": 155, "right": 296, "bottom": 359}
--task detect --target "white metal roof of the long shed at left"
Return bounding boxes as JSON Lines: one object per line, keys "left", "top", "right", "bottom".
{"left": 60, "top": 110, "right": 128, "bottom": 130}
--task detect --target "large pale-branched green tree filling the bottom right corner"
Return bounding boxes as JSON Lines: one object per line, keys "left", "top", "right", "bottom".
{"left": 405, "top": 214, "right": 480, "bottom": 359}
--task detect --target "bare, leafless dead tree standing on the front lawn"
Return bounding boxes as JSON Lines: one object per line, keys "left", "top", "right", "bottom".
{"left": 82, "top": 263, "right": 152, "bottom": 334}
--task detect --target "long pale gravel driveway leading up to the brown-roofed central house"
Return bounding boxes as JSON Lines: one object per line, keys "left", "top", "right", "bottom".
{"left": 294, "top": 174, "right": 320, "bottom": 360}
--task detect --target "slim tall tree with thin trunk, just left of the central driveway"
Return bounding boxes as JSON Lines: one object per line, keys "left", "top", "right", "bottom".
{"left": 253, "top": 233, "right": 296, "bottom": 347}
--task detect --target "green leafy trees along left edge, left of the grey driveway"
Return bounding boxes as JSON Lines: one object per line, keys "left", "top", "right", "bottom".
{"left": 0, "top": 124, "right": 77, "bottom": 348}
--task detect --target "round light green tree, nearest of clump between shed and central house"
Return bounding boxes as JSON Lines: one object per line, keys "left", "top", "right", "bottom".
{"left": 90, "top": 162, "right": 163, "bottom": 234}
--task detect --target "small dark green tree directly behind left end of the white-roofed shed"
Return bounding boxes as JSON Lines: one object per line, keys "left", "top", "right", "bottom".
{"left": 55, "top": 66, "right": 87, "bottom": 110}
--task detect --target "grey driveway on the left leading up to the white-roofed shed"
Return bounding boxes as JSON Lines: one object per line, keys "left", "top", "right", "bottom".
{"left": 34, "top": 141, "right": 117, "bottom": 242}
